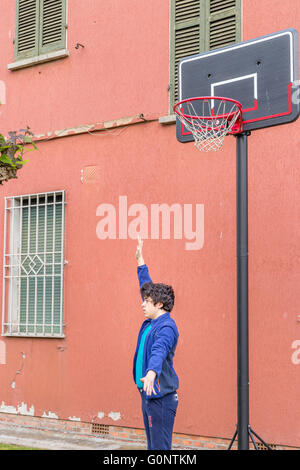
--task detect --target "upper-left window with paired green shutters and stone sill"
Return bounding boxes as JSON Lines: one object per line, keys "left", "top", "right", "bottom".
{"left": 8, "top": 0, "right": 68, "bottom": 69}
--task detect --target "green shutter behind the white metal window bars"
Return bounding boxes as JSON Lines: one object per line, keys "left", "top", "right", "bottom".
{"left": 20, "top": 196, "right": 63, "bottom": 334}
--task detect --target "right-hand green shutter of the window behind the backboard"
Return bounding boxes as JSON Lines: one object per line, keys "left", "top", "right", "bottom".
{"left": 206, "top": 0, "right": 241, "bottom": 49}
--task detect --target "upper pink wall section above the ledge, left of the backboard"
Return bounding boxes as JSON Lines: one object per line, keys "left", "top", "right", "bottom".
{"left": 0, "top": 0, "right": 169, "bottom": 134}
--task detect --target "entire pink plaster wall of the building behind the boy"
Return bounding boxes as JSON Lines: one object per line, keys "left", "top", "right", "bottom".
{"left": 0, "top": 0, "right": 300, "bottom": 446}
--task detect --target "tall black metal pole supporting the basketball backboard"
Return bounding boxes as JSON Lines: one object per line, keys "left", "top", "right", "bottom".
{"left": 236, "top": 132, "right": 250, "bottom": 450}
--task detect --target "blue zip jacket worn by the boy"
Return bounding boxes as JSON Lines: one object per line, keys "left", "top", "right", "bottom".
{"left": 133, "top": 264, "right": 179, "bottom": 398}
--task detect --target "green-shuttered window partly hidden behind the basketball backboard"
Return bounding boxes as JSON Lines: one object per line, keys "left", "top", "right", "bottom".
{"left": 170, "top": 0, "right": 241, "bottom": 109}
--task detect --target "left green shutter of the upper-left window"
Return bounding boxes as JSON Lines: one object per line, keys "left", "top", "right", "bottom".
{"left": 15, "top": 0, "right": 39, "bottom": 60}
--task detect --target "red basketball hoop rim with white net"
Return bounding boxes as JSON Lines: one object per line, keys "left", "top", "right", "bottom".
{"left": 173, "top": 96, "right": 243, "bottom": 152}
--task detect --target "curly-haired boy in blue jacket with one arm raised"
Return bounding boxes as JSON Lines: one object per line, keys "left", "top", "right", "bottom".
{"left": 133, "top": 238, "right": 179, "bottom": 450}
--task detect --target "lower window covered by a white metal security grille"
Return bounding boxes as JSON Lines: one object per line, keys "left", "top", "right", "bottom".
{"left": 2, "top": 191, "right": 65, "bottom": 337}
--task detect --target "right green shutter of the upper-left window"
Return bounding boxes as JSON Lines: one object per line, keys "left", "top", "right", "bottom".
{"left": 39, "top": 0, "right": 66, "bottom": 54}
